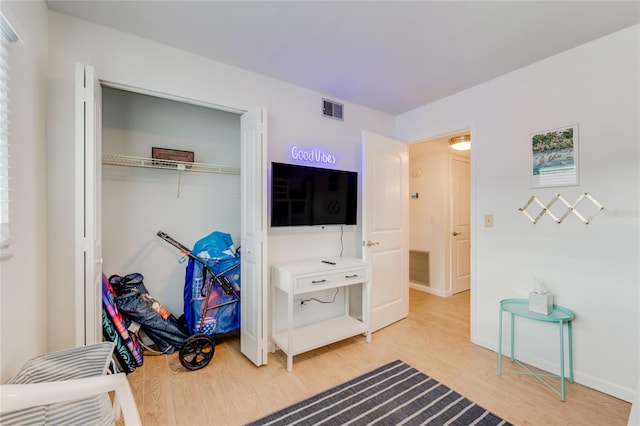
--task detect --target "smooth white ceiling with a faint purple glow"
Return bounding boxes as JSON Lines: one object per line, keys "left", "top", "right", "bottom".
{"left": 47, "top": 0, "right": 640, "bottom": 115}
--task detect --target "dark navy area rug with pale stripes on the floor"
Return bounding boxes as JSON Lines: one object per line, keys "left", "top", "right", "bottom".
{"left": 248, "top": 360, "right": 511, "bottom": 426}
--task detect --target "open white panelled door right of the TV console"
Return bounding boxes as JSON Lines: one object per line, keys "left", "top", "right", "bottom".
{"left": 362, "top": 131, "right": 409, "bottom": 331}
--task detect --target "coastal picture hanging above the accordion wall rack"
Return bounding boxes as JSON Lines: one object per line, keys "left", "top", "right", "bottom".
{"left": 530, "top": 124, "right": 579, "bottom": 188}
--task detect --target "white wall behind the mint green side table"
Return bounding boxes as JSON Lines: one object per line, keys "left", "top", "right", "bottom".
{"left": 396, "top": 25, "right": 640, "bottom": 401}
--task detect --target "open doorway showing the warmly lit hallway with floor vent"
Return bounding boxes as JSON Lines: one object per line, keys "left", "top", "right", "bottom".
{"left": 409, "top": 130, "right": 471, "bottom": 297}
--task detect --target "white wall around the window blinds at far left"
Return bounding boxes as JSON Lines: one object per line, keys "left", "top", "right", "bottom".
{"left": 0, "top": 1, "right": 48, "bottom": 383}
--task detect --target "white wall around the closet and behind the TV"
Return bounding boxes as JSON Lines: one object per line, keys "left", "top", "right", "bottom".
{"left": 47, "top": 12, "right": 395, "bottom": 348}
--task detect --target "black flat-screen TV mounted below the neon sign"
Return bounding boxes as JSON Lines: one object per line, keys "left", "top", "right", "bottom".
{"left": 271, "top": 162, "right": 358, "bottom": 227}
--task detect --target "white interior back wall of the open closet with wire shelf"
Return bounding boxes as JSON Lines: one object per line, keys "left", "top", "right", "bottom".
{"left": 101, "top": 85, "right": 241, "bottom": 346}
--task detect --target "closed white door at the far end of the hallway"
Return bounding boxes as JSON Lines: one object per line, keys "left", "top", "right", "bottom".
{"left": 451, "top": 158, "right": 471, "bottom": 294}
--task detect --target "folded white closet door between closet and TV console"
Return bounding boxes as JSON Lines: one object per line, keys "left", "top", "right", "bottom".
{"left": 240, "top": 109, "right": 268, "bottom": 366}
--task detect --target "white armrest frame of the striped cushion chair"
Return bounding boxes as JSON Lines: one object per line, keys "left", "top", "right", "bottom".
{"left": 0, "top": 373, "right": 142, "bottom": 426}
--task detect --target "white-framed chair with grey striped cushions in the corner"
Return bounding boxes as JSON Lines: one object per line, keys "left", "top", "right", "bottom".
{"left": 0, "top": 342, "right": 141, "bottom": 426}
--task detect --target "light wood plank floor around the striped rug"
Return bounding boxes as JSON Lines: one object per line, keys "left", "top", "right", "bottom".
{"left": 129, "top": 290, "right": 631, "bottom": 426}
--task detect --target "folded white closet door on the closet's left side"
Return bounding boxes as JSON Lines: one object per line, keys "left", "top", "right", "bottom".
{"left": 75, "top": 64, "right": 102, "bottom": 346}
